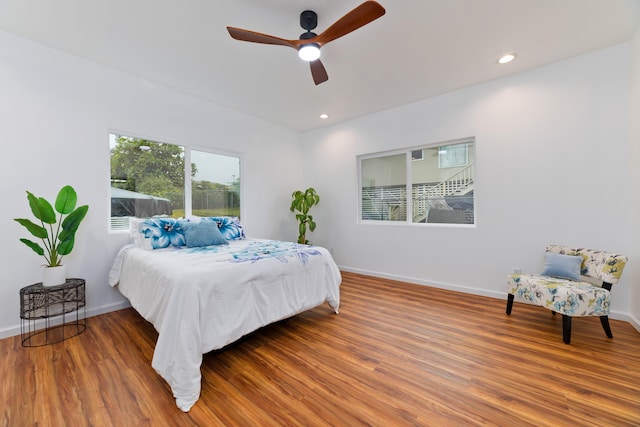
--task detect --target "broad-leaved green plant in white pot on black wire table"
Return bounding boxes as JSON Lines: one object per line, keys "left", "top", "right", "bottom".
{"left": 14, "top": 185, "right": 89, "bottom": 286}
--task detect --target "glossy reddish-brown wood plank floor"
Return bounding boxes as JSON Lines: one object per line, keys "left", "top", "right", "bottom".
{"left": 0, "top": 273, "right": 640, "bottom": 427}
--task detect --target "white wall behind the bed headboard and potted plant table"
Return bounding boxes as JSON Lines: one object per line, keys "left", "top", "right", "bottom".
{"left": 0, "top": 32, "right": 303, "bottom": 337}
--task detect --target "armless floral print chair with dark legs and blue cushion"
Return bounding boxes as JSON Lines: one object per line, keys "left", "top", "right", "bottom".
{"left": 507, "top": 245, "right": 628, "bottom": 344}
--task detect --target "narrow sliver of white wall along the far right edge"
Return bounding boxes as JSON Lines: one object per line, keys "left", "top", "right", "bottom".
{"left": 628, "top": 30, "right": 640, "bottom": 331}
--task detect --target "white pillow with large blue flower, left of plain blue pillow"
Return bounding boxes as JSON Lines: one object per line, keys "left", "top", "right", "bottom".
{"left": 130, "top": 218, "right": 186, "bottom": 250}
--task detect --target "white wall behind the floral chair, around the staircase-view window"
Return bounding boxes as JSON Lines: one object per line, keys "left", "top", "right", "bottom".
{"left": 303, "top": 44, "right": 639, "bottom": 319}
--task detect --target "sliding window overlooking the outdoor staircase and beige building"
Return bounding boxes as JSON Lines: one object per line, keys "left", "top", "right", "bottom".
{"left": 358, "top": 139, "right": 475, "bottom": 224}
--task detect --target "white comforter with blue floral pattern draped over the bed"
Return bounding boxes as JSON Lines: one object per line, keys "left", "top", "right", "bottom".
{"left": 109, "top": 239, "right": 341, "bottom": 412}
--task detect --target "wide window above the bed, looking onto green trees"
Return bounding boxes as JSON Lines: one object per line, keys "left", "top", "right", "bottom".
{"left": 109, "top": 134, "right": 240, "bottom": 230}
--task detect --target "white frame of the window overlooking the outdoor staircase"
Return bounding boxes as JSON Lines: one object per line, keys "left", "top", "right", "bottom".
{"left": 356, "top": 137, "right": 477, "bottom": 228}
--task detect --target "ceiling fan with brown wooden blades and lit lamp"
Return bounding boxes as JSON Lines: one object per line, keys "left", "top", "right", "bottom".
{"left": 227, "top": 1, "right": 385, "bottom": 85}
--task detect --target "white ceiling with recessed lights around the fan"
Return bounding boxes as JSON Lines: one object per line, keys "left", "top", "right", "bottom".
{"left": 0, "top": 0, "right": 640, "bottom": 130}
